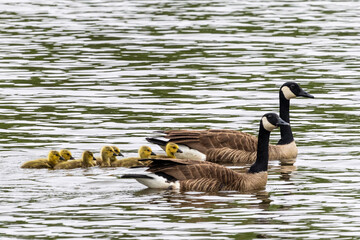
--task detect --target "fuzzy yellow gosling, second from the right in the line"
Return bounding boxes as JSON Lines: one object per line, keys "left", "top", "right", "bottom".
{"left": 111, "top": 146, "right": 155, "bottom": 167}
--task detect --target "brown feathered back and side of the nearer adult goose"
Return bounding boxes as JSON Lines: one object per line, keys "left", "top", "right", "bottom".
{"left": 139, "top": 159, "right": 267, "bottom": 192}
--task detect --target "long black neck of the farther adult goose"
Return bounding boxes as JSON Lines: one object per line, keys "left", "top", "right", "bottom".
{"left": 277, "top": 90, "right": 294, "bottom": 145}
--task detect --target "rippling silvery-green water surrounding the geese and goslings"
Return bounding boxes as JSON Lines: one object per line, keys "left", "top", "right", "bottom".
{"left": 0, "top": 0, "right": 360, "bottom": 239}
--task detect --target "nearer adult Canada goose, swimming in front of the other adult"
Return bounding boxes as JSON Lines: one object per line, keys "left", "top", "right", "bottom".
{"left": 121, "top": 113, "right": 288, "bottom": 192}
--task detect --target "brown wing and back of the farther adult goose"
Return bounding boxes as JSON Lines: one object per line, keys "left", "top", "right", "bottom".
{"left": 164, "top": 129, "right": 257, "bottom": 154}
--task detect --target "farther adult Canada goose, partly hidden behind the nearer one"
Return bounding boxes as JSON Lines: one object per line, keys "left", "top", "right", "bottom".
{"left": 147, "top": 82, "right": 313, "bottom": 163}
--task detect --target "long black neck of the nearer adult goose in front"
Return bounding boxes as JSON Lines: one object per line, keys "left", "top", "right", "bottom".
{"left": 249, "top": 122, "right": 270, "bottom": 173}
